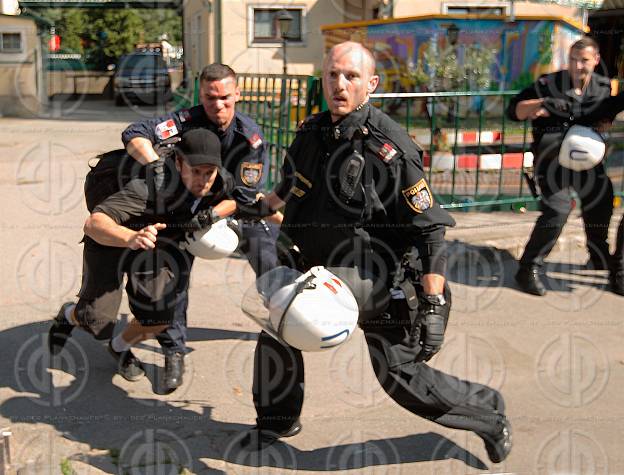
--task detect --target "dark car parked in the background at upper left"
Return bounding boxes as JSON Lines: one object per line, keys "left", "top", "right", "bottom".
{"left": 113, "top": 51, "right": 171, "bottom": 105}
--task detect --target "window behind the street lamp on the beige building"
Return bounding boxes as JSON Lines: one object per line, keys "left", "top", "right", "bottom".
{"left": 249, "top": 5, "right": 303, "bottom": 44}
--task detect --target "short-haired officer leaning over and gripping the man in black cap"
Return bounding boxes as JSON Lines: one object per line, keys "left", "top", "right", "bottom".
{"left": 121, "top": 63, "right": 281, "bottom": 389}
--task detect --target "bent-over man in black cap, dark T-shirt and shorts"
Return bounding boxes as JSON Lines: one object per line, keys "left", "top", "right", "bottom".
{"left": 48, "top": 129, "right": 234, "bottom": 381}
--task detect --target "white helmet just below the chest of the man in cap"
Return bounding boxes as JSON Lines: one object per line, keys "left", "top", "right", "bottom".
{"left": 180, "top": 219, "right": 238, "bottom": 259}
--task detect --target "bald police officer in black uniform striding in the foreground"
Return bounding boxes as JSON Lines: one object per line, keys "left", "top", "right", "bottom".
{"left": 242, "top": 42, "right": 511, "bottom": 462}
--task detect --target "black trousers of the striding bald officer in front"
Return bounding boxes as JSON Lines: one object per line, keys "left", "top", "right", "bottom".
{"left": 253, "top": 301, "right": 505, "bottom": 436}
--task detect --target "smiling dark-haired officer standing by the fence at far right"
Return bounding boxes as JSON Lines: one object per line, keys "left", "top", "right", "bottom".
{"left": 507, "top": 37, "right": 617, "bottom": 296}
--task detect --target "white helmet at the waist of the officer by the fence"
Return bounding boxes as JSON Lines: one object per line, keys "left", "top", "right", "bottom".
{"left": 559, "top": 125, "right": 606, "bottom": 172}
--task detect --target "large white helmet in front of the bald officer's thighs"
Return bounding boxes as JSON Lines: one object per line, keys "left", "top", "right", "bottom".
{"left": 267, "top": 266, "right": 359, "bottom": 351}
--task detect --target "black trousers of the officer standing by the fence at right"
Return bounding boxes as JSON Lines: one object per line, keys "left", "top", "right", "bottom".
{"left": 520, "top": 158, "right": 613, "bottom": 269}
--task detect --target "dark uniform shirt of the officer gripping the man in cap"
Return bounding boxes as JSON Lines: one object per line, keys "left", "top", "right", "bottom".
{"left": 121, "top": 105, "right": 269, "bottom": 196}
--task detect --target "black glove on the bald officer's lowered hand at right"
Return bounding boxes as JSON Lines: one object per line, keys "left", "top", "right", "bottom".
{"left": 412, "top": 295, "right": 448, "bottom": 361}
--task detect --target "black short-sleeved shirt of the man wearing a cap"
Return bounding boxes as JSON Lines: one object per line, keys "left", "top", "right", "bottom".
{"left": 93, "top": 158, "right": 234, "bottom": 247}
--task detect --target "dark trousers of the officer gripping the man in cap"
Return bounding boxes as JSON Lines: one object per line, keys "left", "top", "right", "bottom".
{"left": 156, "top": 222, "right": 279, "bottom": 354}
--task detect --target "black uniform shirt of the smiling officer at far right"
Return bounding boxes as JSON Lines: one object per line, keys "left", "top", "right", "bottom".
{"left": 507, "top": 70, "right": 617, "bottom": 147}
